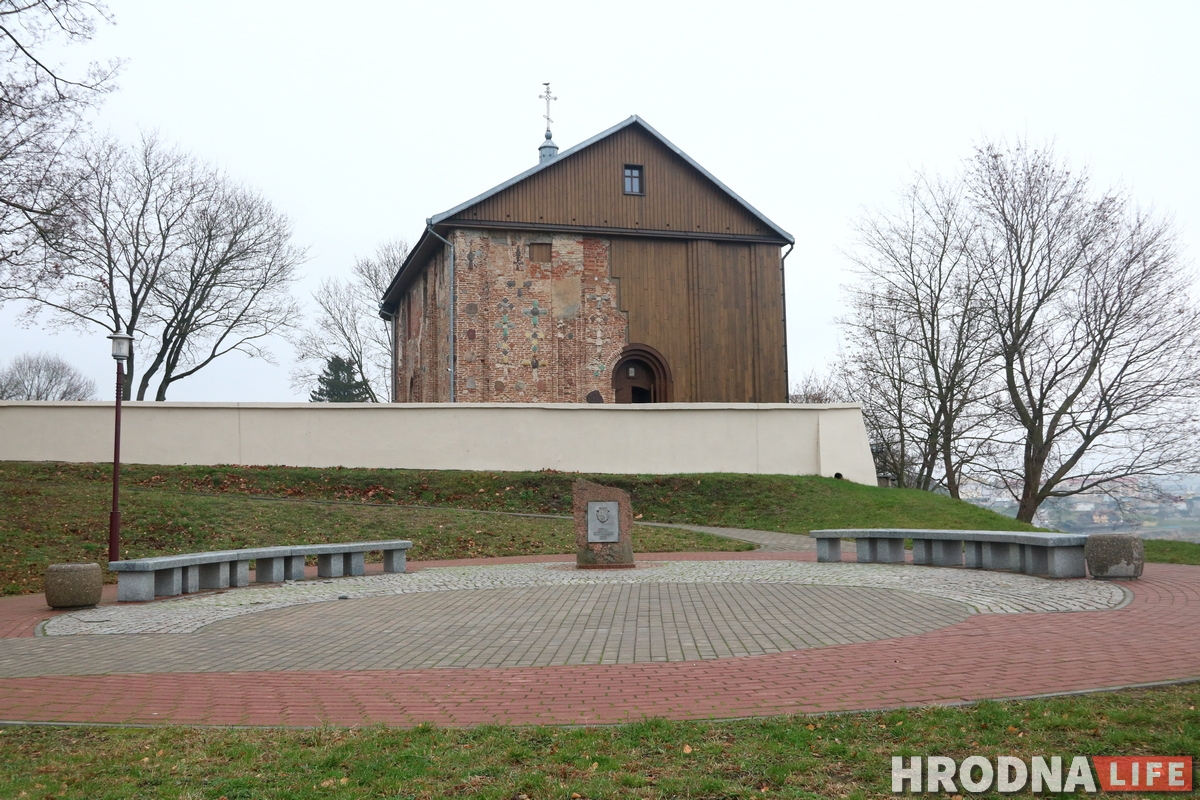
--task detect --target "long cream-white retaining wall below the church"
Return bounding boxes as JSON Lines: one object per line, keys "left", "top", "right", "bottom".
{"left": 0, "top": 402, "right": 875, "bottom": 486}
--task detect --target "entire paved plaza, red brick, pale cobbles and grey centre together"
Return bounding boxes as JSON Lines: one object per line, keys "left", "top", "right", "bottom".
{"left": 0, "top": 531, "right": 1200, "bottom": 726}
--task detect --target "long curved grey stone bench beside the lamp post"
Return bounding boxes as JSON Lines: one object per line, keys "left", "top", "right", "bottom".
{"left": 108, "top": 539, "right": 413, "bottom": 602}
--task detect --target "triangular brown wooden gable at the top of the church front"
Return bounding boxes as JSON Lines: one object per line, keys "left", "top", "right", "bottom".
{"left": 444, "top": 125, "right": 780, "bottom": 241}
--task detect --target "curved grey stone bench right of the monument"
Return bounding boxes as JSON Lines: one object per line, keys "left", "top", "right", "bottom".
{"left": 809, "top": 528, "right": 1087, "bottom": 578}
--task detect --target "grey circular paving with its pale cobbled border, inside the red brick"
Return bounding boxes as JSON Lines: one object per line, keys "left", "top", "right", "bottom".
{"left": 0, "top": 560, "right": 1126, "bottom": 678}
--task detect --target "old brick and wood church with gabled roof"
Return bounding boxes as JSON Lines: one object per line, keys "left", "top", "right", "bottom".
{"left": 380, "top": 112, "right": 794, "bottom": 403}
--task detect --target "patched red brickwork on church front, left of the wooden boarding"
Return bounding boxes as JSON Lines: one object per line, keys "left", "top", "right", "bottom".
{"left": 450, "top": 229, "right": 628, "bottom": 403}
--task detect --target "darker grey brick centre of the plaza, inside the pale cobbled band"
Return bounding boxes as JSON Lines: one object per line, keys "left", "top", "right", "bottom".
{"left": 0, "top": 583, "right": 971, "bottom": 678}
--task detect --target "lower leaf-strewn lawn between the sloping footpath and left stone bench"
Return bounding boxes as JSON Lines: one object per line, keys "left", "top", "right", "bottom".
{"left": 0, "top": 464, "right": 754, "bottom": 594}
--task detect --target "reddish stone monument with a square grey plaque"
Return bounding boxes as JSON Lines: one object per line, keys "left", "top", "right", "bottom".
{"left": 571, "top": 481, "right": 634, "bottom": 570}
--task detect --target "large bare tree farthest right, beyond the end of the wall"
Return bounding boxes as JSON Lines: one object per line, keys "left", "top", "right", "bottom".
{"left": 967, "top": 144, "right": 1200, "bottom": 522}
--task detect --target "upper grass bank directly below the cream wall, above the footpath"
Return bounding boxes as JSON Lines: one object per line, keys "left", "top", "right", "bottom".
{"left": 7, "top": 463, "right": 1031, "bottom": 534}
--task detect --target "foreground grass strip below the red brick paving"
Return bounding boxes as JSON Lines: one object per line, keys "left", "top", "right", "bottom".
{"left": 0, "top": 684, "right": 1200, "bottom": 800}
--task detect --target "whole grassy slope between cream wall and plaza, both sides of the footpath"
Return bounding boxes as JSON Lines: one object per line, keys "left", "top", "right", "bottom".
{"left": 0, "top": 462, "right": 1200, "bottom": 594}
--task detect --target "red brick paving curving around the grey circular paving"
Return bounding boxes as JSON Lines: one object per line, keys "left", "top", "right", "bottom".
{"left": 0, "top": 553, "right": 1200, "bottom": 726}
